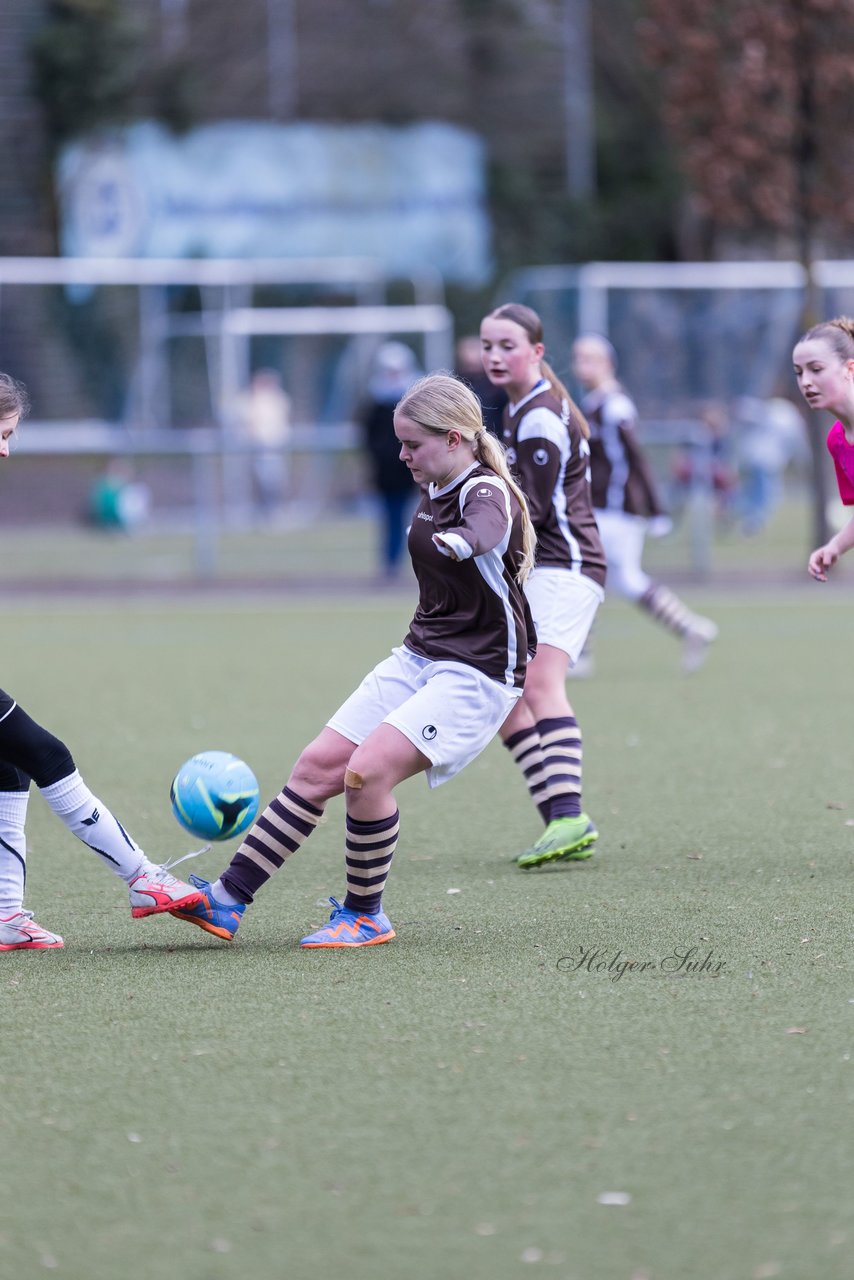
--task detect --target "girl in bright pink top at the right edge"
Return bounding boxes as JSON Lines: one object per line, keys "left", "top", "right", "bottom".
{"left": 791, "top": 316, "right": 854, "bottom": 582}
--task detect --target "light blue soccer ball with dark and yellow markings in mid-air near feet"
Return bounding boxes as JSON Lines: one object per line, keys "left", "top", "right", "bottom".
{"left": 169, "top": 751, "right": 260, "bottom": 840}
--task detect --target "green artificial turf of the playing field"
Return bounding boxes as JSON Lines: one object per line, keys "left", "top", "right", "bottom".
{"left": 0, "top": 588, "right": 854, "bottom": 1280}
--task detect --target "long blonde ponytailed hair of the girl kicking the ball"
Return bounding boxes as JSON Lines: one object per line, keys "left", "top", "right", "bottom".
{"left": 394, "top": 372, "right": 536, "bottom": 585}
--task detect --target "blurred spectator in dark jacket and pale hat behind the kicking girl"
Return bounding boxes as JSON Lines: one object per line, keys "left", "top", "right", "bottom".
{"left": 360, "top": 342, "right": 421, "bottom": 580}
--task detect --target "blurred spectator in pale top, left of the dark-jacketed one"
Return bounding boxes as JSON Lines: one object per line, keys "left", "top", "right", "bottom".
{"left": 236, "top": 369, "right": 291, "bottom": 516}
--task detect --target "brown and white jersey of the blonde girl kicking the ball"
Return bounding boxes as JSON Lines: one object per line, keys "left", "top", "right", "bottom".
{"left": 403, "top": 462, "right": 536, "bottom": 689}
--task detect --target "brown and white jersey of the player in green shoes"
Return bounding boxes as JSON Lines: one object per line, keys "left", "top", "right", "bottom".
{"left": 503, "top": 379, "right": 606, "bottom": 586}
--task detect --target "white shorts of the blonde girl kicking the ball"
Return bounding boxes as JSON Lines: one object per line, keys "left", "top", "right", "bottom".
{"left": 328, "top": 645, "right": 522, "bottom": 787}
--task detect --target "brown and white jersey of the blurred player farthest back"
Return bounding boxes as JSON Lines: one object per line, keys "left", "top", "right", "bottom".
{"left": 581, "top": 383, "right": 665, "bottom": 516}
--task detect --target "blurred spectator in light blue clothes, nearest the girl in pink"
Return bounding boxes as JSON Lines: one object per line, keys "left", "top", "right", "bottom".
{"left": 732, "top": 396, "right": 807, "bottom": 534}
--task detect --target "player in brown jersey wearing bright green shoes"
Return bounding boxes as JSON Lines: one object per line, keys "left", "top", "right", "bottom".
{"left": 480, "top": 303, "right": 606, "bottom": 868}
